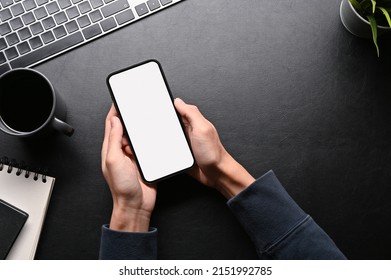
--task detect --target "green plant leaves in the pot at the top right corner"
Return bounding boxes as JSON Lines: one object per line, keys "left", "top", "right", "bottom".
{"left": 349, "top": 0, "right": 391, "bottom": 56}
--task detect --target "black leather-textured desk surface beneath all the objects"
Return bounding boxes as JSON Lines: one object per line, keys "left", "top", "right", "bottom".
{"left": 0, "top": 0, "right": 391, "bottom": 259}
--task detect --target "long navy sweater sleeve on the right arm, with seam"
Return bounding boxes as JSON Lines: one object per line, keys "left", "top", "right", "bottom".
{"left": 227, "top": 171, "right": 345, "bottom": 259}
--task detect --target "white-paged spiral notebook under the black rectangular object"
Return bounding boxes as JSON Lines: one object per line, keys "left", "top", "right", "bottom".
{"left": 0, "top": 158, "right": 55, "bottom": 260}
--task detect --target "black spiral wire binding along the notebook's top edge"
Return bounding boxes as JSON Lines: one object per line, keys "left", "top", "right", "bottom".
{"left": 0, "top": 156, "right": 47, "bottom": 183}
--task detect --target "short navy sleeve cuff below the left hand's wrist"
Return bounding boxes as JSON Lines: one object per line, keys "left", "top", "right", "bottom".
{"left": 99, "top": 225, "right": 157, "bottom": 260}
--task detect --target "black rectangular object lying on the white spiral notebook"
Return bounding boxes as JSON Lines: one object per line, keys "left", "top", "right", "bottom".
{"left": 0, "top": 199, "right": 29, "bottom": 260}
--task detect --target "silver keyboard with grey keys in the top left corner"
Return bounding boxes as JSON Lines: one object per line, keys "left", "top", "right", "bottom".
{"left": 0, "top": 0, "right": 183, "bottom": 75}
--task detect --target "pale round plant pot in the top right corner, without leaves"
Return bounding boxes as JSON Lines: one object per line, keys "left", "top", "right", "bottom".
{"left": 339, "top": 0, "right": 391, "bottom": 39}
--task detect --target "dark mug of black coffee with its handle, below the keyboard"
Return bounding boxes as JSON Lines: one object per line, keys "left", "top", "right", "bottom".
{"left": 0, "top": 68, "right": 74, "bottom": 137}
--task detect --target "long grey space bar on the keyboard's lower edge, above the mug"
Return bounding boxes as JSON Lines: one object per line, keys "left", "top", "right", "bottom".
{"left": 11, "top": 32, "right": 84, "bottom": 68}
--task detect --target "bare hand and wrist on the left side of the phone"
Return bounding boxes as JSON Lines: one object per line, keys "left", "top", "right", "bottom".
{"left": 101, "top": 106, "right": 156, "bottom": 232}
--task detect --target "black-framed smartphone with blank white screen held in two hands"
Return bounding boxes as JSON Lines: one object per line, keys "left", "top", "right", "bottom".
{"left": 107, "top": 60, "right": 194, "bottom": 183}
